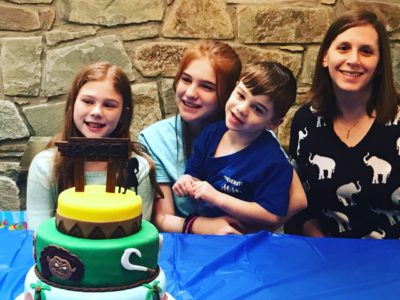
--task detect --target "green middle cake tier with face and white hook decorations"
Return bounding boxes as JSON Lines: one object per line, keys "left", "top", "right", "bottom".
{"left": 35, "top": 218, "right": 160, "bottom": 288}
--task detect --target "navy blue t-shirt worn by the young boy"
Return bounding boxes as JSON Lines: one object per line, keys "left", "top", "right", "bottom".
{"left": 185, "top": 121, "right": 293, "bottom": 216}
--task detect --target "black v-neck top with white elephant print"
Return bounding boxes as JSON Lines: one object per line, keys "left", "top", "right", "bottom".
{"left": 289, "top": 104, "right": 400, "bottom": 238}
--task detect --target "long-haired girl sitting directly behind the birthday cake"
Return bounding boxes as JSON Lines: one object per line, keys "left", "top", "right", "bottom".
{"left": 27, "top": 62, "right": 157, "bottom": 229}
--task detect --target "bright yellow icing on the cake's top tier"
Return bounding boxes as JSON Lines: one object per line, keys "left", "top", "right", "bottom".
{"left": 57, "top": 185, "right": 142, "bottom": 223}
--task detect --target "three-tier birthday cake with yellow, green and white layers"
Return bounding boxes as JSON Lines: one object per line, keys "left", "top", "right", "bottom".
{"left": 24, "top": 185, "right": 167, "bottom": 300}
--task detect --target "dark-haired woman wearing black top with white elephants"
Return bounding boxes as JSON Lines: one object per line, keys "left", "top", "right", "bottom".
{"left": 289, "top": 10, "right": 400, "bottom": 238}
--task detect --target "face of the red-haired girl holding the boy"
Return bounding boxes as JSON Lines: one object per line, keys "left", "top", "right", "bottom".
{"left": 175, "top": 57, "right": 219, "bottom": 130}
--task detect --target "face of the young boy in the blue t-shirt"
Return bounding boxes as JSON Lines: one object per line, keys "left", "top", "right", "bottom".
{"left": 225, "top": 81, "right": 282, "bottom": 135}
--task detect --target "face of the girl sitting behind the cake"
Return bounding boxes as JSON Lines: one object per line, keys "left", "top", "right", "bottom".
{"left": 73, "top": 79, "right": 123, "bottom": 138}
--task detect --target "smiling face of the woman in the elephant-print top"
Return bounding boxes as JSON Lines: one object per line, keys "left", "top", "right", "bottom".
{"left": 322, "top": 24, "right": 379, "bottom": 97}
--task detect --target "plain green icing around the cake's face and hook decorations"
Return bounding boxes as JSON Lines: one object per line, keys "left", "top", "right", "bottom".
{"left": 35, "top": 218, "right": 159, "bottom": 287}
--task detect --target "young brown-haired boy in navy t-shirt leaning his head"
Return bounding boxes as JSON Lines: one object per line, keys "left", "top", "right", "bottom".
{"left": 173, "top": 62, "right": 296, "bottom": 232}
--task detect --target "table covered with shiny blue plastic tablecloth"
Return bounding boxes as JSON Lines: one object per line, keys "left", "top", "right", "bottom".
{"left": 0, "top": 230, "right": 400, "bottom": 300}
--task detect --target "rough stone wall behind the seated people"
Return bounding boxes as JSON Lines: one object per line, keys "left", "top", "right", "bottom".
{"left": 0, "top": 0, "right": 400, "bottom": 209}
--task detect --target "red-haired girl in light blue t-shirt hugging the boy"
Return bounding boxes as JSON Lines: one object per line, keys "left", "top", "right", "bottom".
{"left": 139, "top": 41, "right": 305, "bottom": 234}
